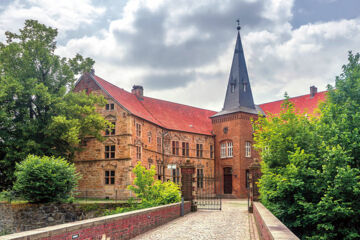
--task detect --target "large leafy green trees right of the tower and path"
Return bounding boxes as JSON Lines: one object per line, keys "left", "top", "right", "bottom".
{"left": 255, "top": 52, "right": 360, "bottom": 239}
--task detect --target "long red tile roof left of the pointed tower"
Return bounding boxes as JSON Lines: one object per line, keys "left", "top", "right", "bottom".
{"left": 94, "top": 76, "right": 216, "bottom": 135}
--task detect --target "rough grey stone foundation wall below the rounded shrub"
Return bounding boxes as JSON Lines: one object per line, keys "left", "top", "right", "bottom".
{"left": 0, "top": 203, "right": 126, "bottom": 233}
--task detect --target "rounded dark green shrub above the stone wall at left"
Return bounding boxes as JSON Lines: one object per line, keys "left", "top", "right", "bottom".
{"left": 14, "top": 155, "right": 80, "bottom": 202}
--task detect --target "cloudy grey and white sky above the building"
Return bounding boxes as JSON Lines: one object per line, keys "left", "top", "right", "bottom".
{"left": 0, "top": 0, "right": 360, "bottom": 111}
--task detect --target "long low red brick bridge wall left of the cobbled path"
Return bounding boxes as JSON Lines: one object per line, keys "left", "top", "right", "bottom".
{"left": 0, "top": 202, "right": 191, "bottom": 240}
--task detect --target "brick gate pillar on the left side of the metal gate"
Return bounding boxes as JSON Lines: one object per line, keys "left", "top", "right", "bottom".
{"left": 180, "top": 160, "right": 196, "bottom": 211}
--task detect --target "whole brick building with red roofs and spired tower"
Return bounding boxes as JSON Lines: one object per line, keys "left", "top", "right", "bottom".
{"left": 74, "top": 27, "right": 325, "bottom": 198}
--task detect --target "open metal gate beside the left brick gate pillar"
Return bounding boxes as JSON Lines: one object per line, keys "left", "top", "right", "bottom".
{"left": 195, "top": 174, "right": 222, "bottom": 210}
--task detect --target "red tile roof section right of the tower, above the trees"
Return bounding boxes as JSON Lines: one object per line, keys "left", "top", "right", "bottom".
{"left": 260, "top": 91, "right": 327, "bottom": 114}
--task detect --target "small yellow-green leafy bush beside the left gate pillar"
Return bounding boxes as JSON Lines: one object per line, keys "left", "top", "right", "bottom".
{"left": 128, "top": 162, "right": 181, "bottom": 207}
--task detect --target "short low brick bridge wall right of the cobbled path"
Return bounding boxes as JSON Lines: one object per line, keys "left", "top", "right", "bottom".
{"left": 253, "top": 202, "right": 299, "bottom": 240}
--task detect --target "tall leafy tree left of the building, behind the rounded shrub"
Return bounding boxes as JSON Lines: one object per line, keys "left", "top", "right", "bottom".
{"left": 0, "top": 20, "right": 107, "bottom": 190}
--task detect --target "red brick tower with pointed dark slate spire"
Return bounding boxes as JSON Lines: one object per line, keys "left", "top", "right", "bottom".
{"left": 211, "top": 21, "right": 262, "bottom": 198}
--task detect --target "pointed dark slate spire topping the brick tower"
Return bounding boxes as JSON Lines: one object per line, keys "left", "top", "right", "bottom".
{"left": 215, "top": 20, "right": 258, "bottom": 116}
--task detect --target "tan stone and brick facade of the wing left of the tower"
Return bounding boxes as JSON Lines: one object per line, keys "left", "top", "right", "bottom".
{"left": 74, "top": 74, "right": 215, "bottom": 199}
